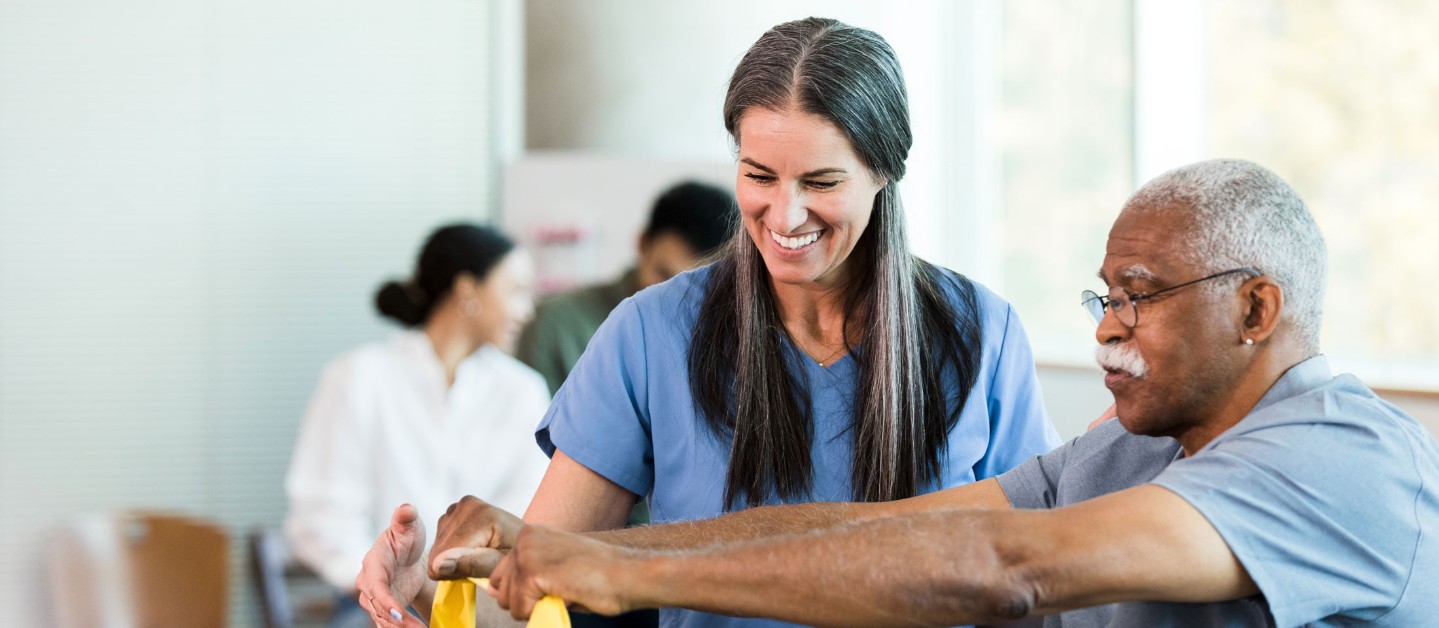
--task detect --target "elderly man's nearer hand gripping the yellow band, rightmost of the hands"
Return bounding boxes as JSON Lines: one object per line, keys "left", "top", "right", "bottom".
{"left": 489, "top": 526, "right": 643, "bottom": 619}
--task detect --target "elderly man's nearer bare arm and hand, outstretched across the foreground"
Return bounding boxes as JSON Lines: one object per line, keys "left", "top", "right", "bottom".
{"left": 492, "top": 485, "right": 1256, "bottom": 627}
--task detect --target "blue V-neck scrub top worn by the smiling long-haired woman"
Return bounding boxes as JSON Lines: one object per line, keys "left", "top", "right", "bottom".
{"left": 535, "top": 266, "right": 1059, "bottom": 628}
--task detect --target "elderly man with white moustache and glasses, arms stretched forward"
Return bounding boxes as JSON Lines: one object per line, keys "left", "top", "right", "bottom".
{"left": 362, "top": 160, "right": 1439, "bottom": 627}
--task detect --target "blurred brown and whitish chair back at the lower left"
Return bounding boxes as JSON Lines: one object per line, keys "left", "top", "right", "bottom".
{"left": 47, "top": 513, "right": 230, "bottom": 628}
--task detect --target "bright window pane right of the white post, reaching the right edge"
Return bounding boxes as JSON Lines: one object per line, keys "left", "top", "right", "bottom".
{"left": 1203, "top": 0, "right": 1439, "bottom": 387}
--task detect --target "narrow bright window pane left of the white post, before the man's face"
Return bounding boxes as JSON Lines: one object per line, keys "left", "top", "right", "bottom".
{"left": 994, "top": 0, "right": 1134, "bottom": 363}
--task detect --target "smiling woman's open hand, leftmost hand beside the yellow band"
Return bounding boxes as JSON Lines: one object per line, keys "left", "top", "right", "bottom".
{"left": 355, "top": 504, "right": 427, "bottom": 628}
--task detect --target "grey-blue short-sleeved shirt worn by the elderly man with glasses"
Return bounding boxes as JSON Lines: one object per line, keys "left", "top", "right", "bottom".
{"left": 999, "top": 357, "right": 1439, "bottom": 628}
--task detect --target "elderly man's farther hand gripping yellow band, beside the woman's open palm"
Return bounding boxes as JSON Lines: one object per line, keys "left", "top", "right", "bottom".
{"left": 430, "top": 495, "right": 525, "bottom": 580}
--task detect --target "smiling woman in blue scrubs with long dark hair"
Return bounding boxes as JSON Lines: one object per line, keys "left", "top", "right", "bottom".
{"left": 360, "top": 19, "right": 1058, "bottom": 627}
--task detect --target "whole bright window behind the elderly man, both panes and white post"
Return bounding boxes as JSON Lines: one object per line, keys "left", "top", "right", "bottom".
{"left": 990, "top": 0, "right": 1439, "bottom": 389}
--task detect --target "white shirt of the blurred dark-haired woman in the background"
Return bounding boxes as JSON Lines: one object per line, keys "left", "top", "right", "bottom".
{"left": 285, "top": 331, "right": 550, "bottom": 591}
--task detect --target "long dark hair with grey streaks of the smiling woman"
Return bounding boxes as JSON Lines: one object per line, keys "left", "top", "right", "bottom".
{"left": 689, "top": 17, "right": 981, "bottom": 508}
